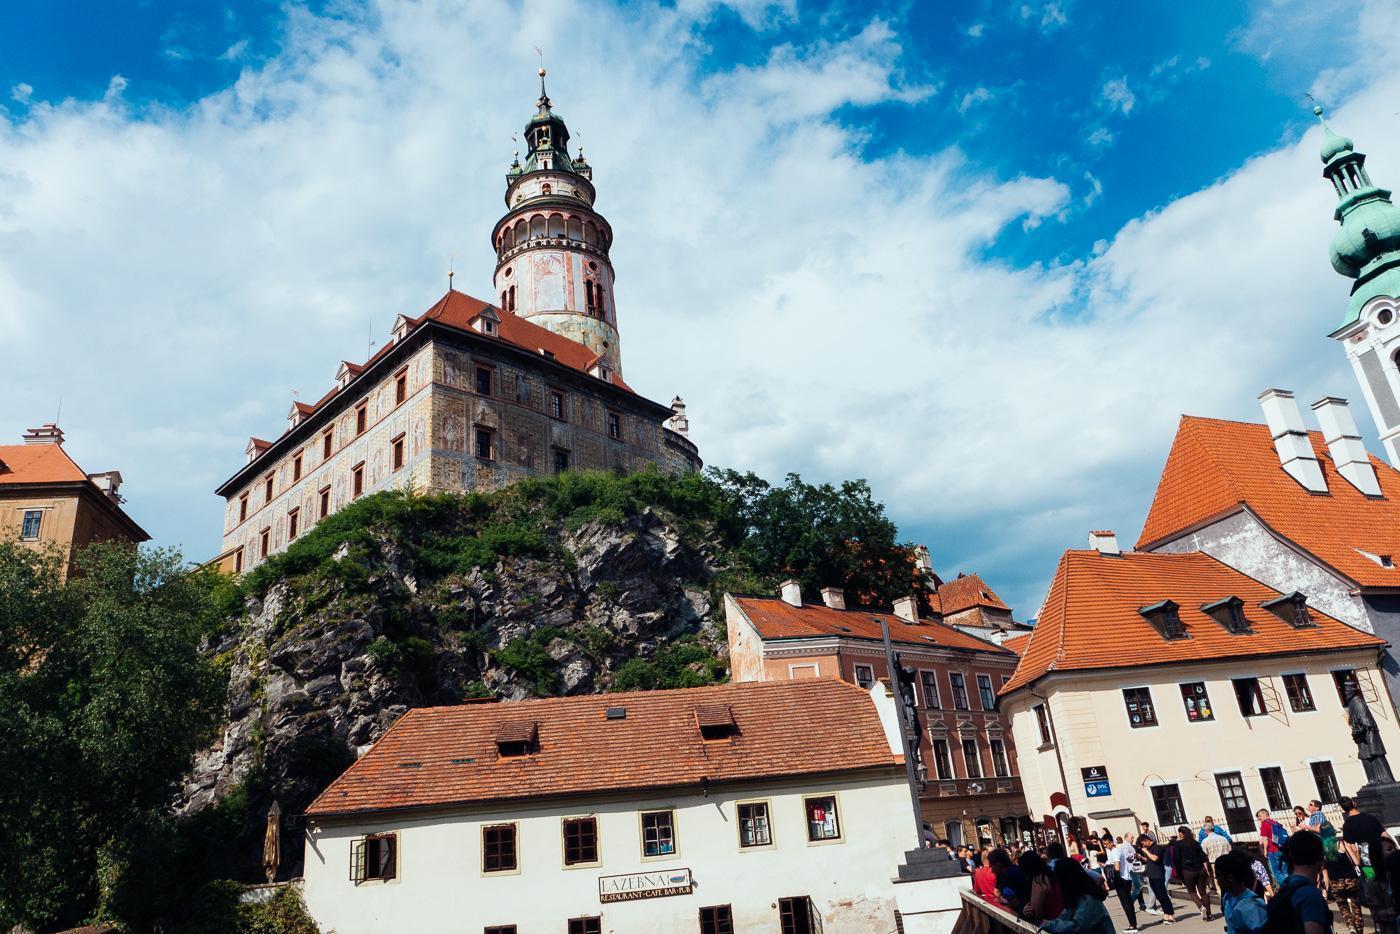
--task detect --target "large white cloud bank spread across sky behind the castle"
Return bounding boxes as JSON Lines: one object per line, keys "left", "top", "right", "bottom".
{"left": 0, "top": 0, "right": 1400, "bottom": 612}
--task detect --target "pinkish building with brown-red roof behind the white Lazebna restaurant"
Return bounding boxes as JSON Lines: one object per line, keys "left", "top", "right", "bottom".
{"left": 724, "top": 578, "right": 1029, "bottom": 843}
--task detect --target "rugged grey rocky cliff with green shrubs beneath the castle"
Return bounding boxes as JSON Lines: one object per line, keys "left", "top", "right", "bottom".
{"left": 176, "top": 478, "right": 734, "bottom": 871}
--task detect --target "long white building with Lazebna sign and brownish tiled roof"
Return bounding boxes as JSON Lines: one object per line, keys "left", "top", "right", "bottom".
{"left": 305, "top": 679, "right": 917, "bottom": 934}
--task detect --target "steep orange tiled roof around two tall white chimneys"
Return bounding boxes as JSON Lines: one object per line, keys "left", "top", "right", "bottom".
{"left": 1138, "top": 416, "right": 1400, "bottom": 587}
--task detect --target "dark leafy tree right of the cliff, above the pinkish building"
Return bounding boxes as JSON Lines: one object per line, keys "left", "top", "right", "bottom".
{"left": 710, "top": 471, "right": 916, "bottom": 606}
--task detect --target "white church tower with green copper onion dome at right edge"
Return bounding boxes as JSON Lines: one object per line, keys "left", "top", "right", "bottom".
{"left": 1313, "top": 106, "right": 1400, "bottom": 466}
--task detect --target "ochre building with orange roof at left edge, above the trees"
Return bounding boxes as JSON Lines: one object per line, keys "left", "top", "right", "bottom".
{"left": 0, "top": 424, "right": 150, "bottom": 573}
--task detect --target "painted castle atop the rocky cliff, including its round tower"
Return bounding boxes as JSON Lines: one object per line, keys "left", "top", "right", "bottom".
{"left": 216, "top": 70, "right": 701, "bottom": 573}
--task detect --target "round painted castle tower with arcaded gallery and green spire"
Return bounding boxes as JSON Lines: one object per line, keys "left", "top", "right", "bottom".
{"left": 491, "top": 69, "right": 622, "bottom": 374}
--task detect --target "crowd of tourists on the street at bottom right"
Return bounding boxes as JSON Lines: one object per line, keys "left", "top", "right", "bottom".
{"left": 957, "top": 798, "right": 1400, "bottom": 934}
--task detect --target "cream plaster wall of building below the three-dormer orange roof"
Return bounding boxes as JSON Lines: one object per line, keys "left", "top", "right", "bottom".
{"left": 1005, "top": 651, "right": 1400, "bottom": 832}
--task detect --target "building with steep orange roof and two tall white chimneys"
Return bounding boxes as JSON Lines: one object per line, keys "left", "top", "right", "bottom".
{"left": 1137, "top": 389, "right": 1400, "bottom": 705}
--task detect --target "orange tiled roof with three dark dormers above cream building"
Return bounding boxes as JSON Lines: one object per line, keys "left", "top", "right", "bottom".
{"left": 1002, "top": 550, "right": 1386, "bottom": 693}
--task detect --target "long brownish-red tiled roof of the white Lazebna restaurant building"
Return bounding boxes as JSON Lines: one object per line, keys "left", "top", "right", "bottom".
{"left": 307, "top": 678, "right": 903, "bottom": 816}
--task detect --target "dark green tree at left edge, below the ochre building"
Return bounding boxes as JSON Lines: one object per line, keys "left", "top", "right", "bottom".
{"left": 0, "top": 542, "right": 223, "bottom": 930}
